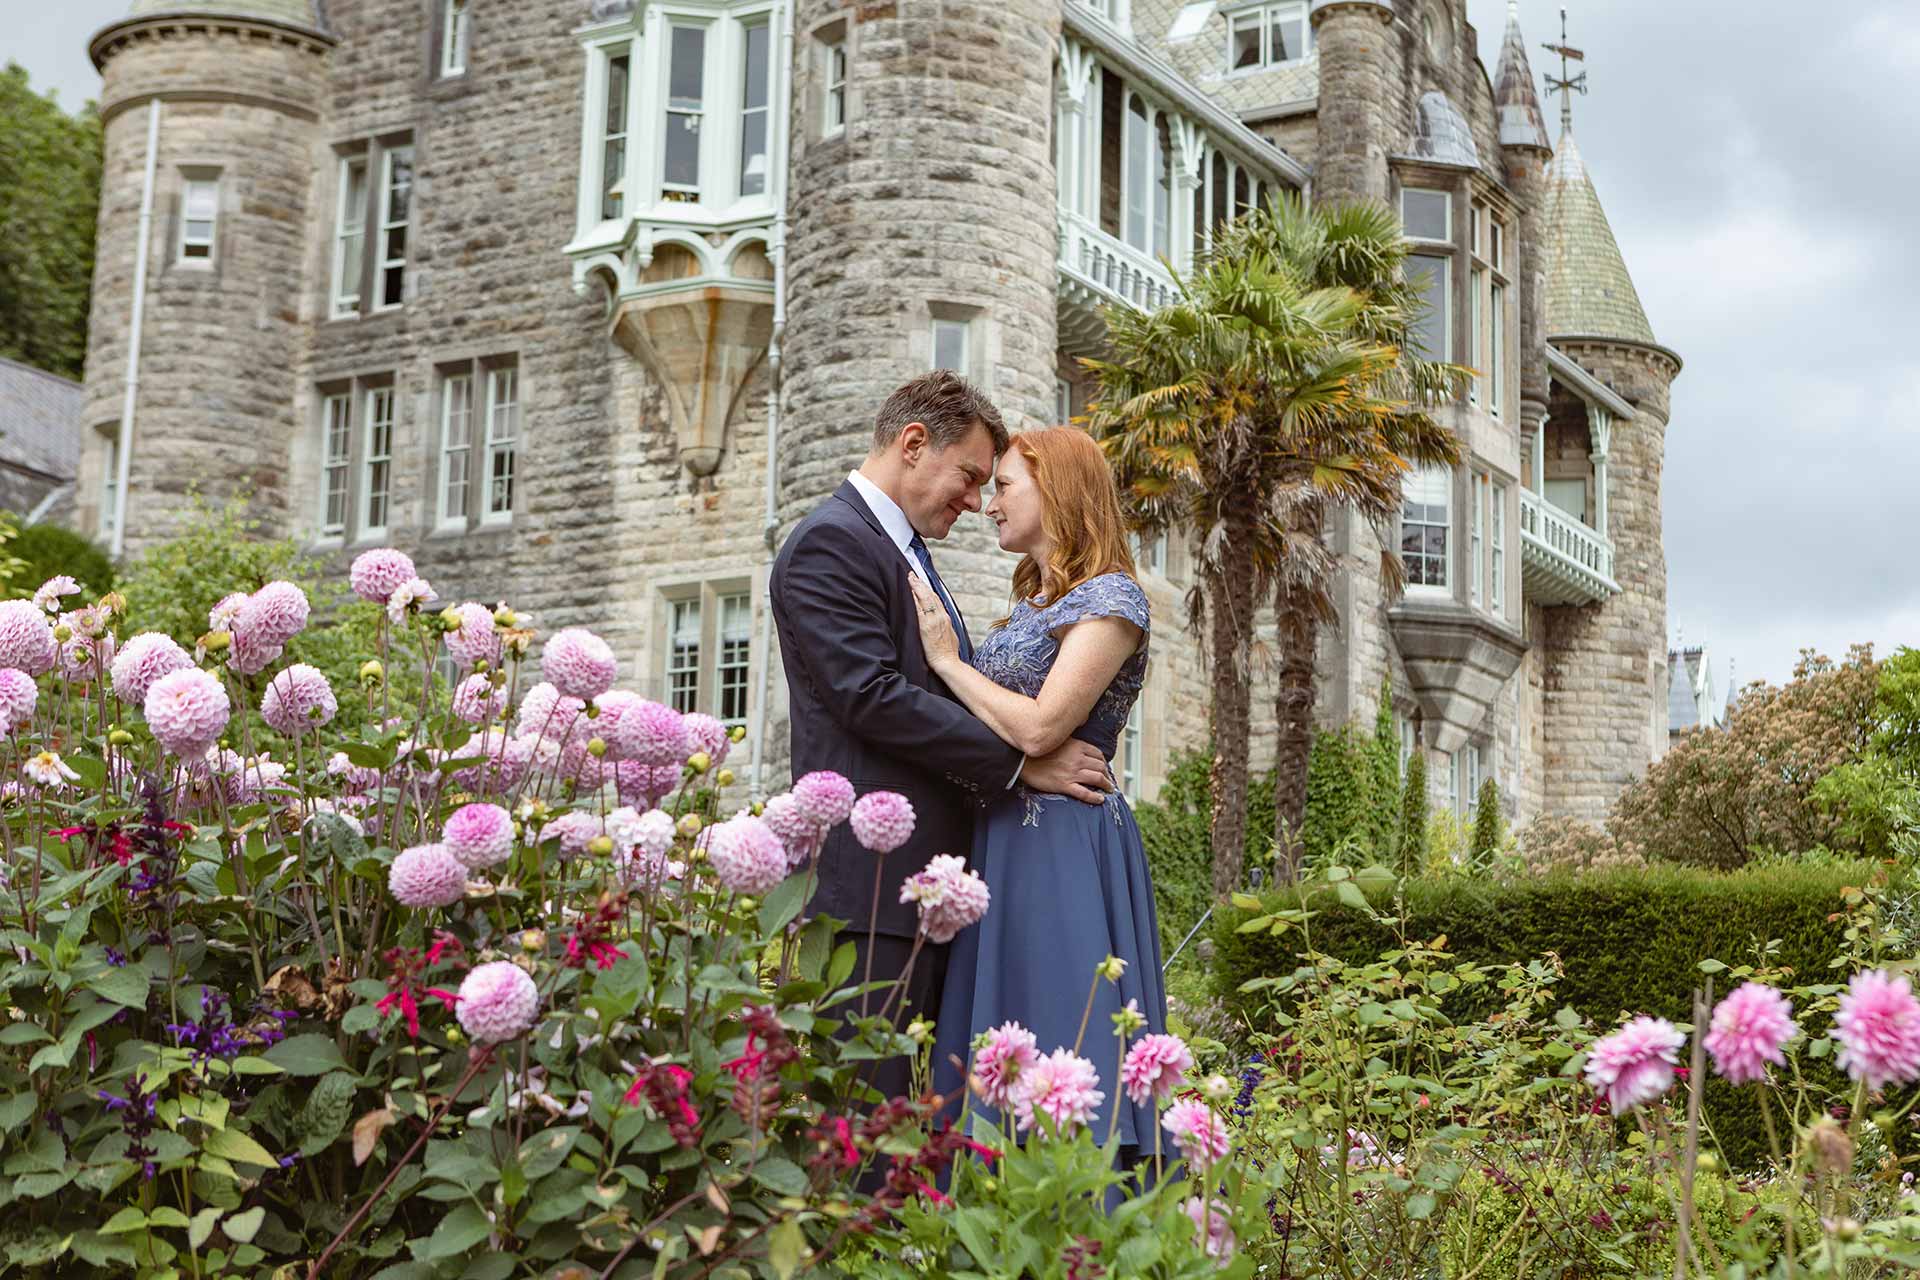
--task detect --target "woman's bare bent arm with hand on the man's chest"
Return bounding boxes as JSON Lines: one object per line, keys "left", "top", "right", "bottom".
{"left": 908, "top": 574, "right": 1142, "bottom": 756}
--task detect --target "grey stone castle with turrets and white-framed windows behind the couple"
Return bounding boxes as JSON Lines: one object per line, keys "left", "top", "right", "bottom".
{"left": 77, "top": 0, "right": 1680, "bottom": 832}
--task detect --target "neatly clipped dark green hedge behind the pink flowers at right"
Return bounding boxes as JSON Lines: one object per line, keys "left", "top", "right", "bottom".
{"left": 1213, "top": 864, "right": 1874, "bottom": 1167}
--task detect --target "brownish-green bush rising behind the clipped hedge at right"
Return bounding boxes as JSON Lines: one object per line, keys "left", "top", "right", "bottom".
{"left": 1609, "top": 645, "right": 1880, "bottom": 867}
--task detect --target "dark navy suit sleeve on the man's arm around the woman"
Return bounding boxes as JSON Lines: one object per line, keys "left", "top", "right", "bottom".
{"left": 780, "top": 524, "right": 1021, "bottom": 791}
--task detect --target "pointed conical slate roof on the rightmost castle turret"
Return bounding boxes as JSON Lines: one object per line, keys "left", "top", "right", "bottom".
{"left": 1540, "top": 130, "right": 1659, "bottom": 345}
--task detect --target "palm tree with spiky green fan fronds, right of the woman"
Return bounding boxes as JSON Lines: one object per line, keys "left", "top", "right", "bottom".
{"left": 1083, "top": 202, "right": 1457, "bottom": 894}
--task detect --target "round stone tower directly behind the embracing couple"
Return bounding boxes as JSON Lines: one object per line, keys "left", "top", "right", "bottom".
{"left": 780, "top": 0, "right": 1060, "bottom": 631}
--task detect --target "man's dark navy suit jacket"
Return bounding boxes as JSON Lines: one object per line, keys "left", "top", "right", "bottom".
{"left": 772, "top": 482, "right": 1021, "bottom": 936}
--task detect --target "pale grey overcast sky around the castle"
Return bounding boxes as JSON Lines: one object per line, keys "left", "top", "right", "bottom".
{"left": 15, "top": 0, "right": 1920, "bottom": 702}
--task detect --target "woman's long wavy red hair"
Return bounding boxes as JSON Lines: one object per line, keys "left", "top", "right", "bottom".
{"left": 993, "top": 426, "right": 1135, "bottom": 628}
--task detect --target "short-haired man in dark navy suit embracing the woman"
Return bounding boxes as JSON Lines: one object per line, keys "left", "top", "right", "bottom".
{"left": 772, "top": 370, "right": 1112, "bottom": 1098}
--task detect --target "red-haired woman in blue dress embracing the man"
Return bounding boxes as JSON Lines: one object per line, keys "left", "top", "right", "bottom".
{"left": 914, "top": 426, "right": 1165, "bottom": 1151}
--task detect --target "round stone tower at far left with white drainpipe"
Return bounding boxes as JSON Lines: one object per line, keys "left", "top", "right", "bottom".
{"left": 79, "top": 0, "right": 332, "bottom": 551}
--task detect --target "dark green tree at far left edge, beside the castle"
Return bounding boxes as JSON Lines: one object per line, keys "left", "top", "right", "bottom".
{"left": 0, "top": 61, "right": 100, "bottom": 378}
